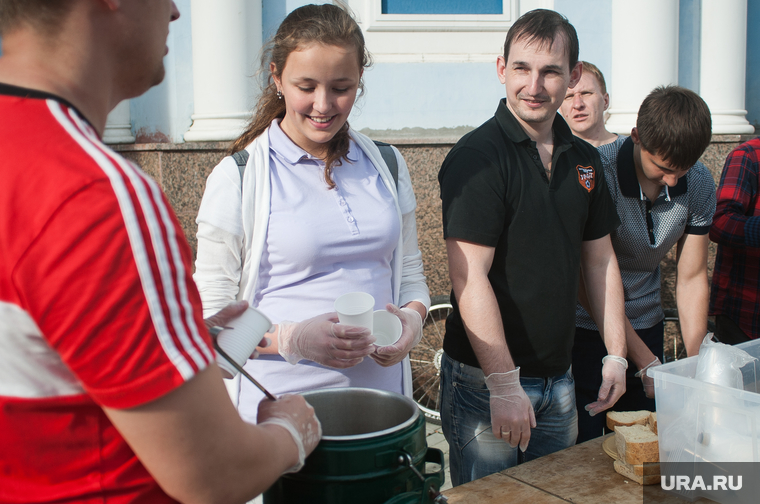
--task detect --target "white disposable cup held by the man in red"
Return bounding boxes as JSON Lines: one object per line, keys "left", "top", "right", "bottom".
{"left": 216, "top": 307, "right": 272, "bottom": 378}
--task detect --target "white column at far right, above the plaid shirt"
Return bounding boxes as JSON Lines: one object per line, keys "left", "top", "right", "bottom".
{"left": 699, "top": 0, "right": 755, "bottom": 135}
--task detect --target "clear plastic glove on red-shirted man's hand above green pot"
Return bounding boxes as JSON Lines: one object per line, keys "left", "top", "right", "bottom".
{"left": 258, "top": 395, "right": 322, "bottom": 473}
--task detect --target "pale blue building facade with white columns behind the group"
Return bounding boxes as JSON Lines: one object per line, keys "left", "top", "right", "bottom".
{"left": 99, "top": 0, "right": 760, "bottom": 143}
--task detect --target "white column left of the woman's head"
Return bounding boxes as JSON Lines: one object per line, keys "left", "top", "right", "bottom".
{"left": 185, "top": 0, "right": 262, "bottom": 142}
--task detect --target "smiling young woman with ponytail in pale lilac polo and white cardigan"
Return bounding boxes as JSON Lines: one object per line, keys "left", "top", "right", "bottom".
{"left": 194, "top": 4, "right": 430, "bottom": 421}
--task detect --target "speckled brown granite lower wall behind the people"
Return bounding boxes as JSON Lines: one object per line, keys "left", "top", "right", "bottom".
{"left": 114, "top": 135, "right": 751, "bottom": 355}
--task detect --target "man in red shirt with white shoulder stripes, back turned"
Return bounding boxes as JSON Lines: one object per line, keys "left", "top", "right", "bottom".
{"left": 0, "top": 0, "right": 319, "bottom": 503}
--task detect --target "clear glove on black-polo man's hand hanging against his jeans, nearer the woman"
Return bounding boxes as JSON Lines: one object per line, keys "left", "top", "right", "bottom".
{"left": 486, "top": 367, "right": 536, "bottom": 452}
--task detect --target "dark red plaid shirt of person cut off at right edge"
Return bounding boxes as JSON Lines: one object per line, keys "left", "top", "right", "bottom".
{"left": 710, "top": 139, "right": 760, "bottom": 247}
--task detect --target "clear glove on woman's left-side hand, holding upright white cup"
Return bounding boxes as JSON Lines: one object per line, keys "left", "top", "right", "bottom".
{"left": 277, "top": 313, "right": 375, "bottom": 369}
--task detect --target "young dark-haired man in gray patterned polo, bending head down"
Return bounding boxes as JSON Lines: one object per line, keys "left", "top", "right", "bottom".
{"left": 573, "top": 86, "right": 715, "bottom": 443}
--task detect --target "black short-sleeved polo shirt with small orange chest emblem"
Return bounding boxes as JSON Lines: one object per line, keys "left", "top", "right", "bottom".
{"left": 438, "top": 99, "right": 619, "bottom": 377}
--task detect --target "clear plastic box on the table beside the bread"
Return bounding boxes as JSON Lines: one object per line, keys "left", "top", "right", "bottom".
{"left": 649, "top": 340, "right": 760, "bottom": 462}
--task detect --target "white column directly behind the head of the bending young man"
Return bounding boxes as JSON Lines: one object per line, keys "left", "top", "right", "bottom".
{"left": 606, "top": 0, "right": 678, "bottom": 135}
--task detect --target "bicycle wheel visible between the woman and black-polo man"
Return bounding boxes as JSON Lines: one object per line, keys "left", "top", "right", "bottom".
{"left": 409, "top": 296, "right": 452, "bottom": 424}
